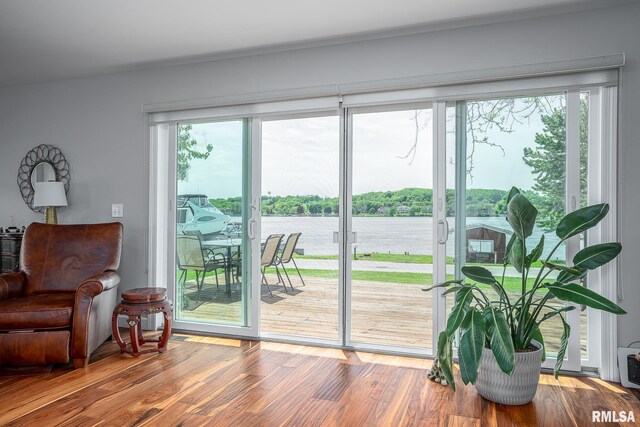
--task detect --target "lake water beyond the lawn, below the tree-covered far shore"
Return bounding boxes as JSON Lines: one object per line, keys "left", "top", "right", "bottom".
{"left": 261, "top": 216, "right": 564, "bottom": 260}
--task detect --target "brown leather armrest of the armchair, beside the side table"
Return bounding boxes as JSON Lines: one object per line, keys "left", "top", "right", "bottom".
{"left": 71, "top": 271, "right": 120, "bottom": 359}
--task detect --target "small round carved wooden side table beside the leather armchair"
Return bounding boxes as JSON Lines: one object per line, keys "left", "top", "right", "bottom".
{"left": 111, "top": 288, "right": 173, "bottom": 357}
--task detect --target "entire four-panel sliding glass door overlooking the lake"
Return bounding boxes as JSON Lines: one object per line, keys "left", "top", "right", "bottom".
{"left": 152, "top": 83, "right": 603, "bottom": 370}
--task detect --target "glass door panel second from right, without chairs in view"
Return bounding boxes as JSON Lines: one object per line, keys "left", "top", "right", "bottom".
{"left": 347, "top": 108, "right": 434, "bottom": 352}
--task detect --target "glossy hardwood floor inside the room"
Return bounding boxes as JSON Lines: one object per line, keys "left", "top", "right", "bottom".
{"left": 0, "top": 335, "right": 640, "bottom": 426}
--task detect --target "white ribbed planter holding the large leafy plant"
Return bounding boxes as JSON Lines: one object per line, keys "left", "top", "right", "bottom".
{"left": 476, "top": 341, "right": 542, "bottom": 405}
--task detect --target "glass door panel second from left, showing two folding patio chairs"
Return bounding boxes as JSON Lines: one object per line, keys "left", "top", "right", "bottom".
{"left": 260, "top": 116, "right": 341, "bottom": 342}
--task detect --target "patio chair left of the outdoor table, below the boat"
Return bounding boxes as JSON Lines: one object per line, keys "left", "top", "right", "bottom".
{"left": 176, "top": 234, "right": 227, "bottom": 301}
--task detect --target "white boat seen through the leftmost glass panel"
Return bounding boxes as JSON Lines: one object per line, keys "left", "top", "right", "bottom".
{"left": 176, "top": 194, "right": 231, "bottom": 240}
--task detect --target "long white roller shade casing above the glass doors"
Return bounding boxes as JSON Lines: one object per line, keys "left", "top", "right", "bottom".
{"left": 142, "top": 54, "right": 625, "bottom": 124}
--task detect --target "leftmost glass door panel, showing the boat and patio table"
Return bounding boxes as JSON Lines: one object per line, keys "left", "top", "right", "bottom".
{"left": 175, "top": 120, "right": 251, "bottom": 326}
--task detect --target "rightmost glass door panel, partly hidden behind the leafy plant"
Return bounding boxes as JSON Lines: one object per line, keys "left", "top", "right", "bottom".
{"left": 447, "top": 94, "right": 580, "bottom": 369}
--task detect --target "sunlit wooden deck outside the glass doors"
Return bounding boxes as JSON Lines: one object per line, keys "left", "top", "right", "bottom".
{"left": 178, "top": 276, "right": 586, "bottom": 352}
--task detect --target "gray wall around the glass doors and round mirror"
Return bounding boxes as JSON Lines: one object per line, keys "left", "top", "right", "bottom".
{"left": 0, "top": 3, "right": 640, "bottom": 345}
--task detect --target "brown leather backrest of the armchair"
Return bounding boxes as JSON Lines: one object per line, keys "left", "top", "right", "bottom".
{"left": 20, "top": 222, "right": 123, "bottom": 295}
